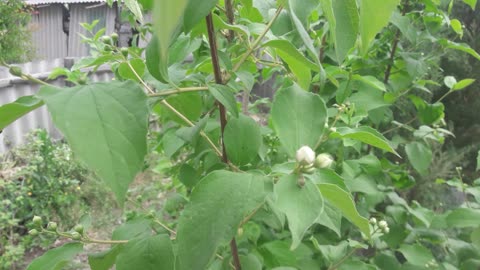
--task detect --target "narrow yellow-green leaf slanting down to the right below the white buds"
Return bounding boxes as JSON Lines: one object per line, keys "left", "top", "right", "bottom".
{"left": 317, "top": 184, "right": 370, "bottom": 237}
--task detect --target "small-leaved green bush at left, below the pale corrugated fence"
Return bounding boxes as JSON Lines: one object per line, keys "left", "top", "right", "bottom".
{"left": 0, "top": 130, "right": 108, "bottom": 269}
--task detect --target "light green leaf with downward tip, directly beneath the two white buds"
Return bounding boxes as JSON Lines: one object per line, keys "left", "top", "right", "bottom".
{"left": 274, "top": 174, "right": 323, "bottom": 250}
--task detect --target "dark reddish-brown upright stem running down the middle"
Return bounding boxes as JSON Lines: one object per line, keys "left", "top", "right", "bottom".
{"left": 206, "top": 12, "right": 242, "bottom": 270}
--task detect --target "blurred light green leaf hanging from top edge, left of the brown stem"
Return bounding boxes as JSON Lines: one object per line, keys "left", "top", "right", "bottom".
{"left": 153, "top": 0, "right": 188, "bottom": 83}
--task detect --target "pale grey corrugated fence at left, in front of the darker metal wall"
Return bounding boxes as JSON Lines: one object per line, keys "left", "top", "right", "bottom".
{"left": 0, "top": 58, "right": 113, "bottom": 153}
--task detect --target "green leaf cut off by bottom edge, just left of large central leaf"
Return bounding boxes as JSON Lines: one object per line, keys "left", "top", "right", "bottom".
{"left": 115, "top": 234, "right": 175, "bottom": 270}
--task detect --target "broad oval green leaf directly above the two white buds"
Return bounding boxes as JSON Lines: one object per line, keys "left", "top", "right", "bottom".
{"left": 272, "top": 84, "right": 327, "bottom": 156}
